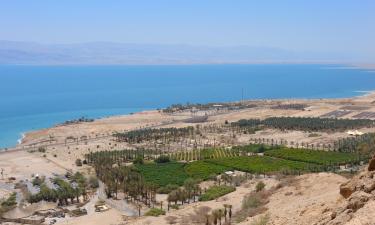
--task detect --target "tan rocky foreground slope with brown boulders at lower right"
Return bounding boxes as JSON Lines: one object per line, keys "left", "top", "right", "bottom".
{"left": 241, "top": 157, "right": 375, "bottom": 225}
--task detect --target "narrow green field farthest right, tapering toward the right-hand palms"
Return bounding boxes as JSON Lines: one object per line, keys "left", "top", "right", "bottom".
{"left": 264, "top": 148, "right": 358, "bottom": 165}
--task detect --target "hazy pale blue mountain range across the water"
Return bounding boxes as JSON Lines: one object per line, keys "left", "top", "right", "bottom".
{"left": 0, "top": 41, "right": 364, "bottom": 65}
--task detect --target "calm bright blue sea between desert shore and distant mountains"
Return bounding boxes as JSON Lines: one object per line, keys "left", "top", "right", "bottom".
{"left": 0, "top": 65, "right": 375, "bottom": 147}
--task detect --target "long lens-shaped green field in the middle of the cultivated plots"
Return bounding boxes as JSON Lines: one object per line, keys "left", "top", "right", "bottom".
{"left": 206, "top": 156, "right": 317, "bottom": 173}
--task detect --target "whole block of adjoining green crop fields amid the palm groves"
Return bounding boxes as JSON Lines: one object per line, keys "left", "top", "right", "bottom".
{"left": 136, "top": 145, "right": 358, "bottom": 187}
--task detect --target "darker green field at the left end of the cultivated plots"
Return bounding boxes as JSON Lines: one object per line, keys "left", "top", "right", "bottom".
{"left": 136, "top": 162, "right": 189, "bottom": 187}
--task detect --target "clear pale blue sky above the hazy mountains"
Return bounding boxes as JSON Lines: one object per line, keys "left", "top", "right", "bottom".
{"left": 0, "top": 0, "right": 375, "bottom": 62}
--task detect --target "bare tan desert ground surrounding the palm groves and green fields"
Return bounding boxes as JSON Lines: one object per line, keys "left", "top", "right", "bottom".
{"left": 0, "top": 93, "right": 375, "bottom": 225}
